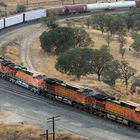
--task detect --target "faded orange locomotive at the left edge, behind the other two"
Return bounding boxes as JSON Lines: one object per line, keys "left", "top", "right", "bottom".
{"left": 0, "top": 57, "right": 46, "bottom": 92}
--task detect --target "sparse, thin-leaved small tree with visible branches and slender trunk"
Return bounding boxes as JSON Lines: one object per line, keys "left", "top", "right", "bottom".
{"left": 118, "top": 61, "right": 136, "bottom": 88}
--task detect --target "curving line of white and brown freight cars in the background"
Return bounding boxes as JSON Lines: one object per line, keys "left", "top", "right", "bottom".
{"left": 0, "top": 0, "right": 140, "bottom": 29}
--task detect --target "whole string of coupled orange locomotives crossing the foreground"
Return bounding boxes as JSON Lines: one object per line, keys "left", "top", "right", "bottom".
{"left": 0, "top": 57, "right": 140, "bottom": 129}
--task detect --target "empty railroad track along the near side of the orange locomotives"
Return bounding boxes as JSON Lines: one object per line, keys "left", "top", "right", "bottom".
{"left": 0, "top": 78, "right": 138, "bottom": 131}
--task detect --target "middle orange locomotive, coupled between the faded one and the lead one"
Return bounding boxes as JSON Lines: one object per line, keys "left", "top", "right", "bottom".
{"left": 46, "top": 78, "right": 94, "bottom": 109}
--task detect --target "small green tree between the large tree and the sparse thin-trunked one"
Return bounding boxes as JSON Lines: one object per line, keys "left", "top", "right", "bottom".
{"left": 103, "top": 61, "right": 120, "bottom": 86}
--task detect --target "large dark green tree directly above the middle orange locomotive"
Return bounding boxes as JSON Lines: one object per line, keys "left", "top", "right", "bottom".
{"left": 55, "top": 48, "right": 93, "bottom": 80}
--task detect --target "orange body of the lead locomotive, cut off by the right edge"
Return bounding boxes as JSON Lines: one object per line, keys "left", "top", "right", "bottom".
{"left": 105, "top": 100, "right": 140, "bottom": 127}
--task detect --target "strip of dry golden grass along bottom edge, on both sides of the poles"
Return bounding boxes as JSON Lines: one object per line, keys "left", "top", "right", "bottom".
{"left": 0, "top": 124, "right": 88, "bottom": 140}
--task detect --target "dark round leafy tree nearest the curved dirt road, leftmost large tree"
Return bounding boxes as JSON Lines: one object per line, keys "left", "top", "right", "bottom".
{"left": 40, "top": 27, "right": 74, "bottom": 55}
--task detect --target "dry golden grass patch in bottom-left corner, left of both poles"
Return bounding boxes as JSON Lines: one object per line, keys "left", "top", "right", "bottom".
{"left": 0, "top": 124, "right": 41, "bottom": 140}
